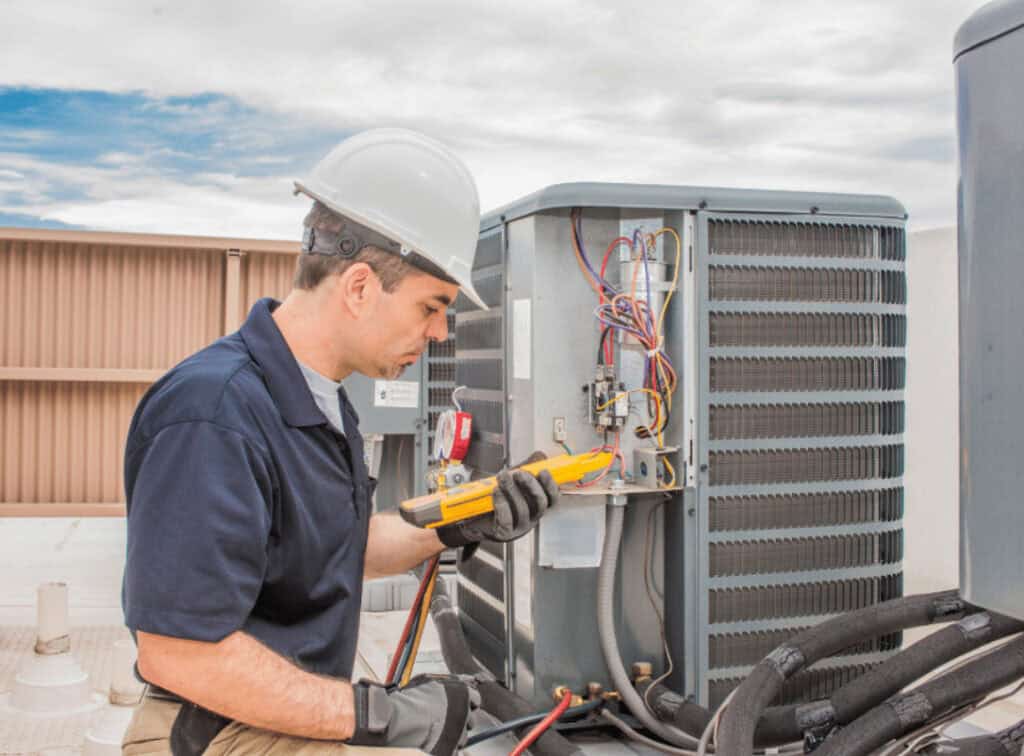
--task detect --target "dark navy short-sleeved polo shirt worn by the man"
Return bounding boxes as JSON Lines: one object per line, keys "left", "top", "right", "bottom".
{"left": 122, "top": 299, "right": 374, "bottom": 677}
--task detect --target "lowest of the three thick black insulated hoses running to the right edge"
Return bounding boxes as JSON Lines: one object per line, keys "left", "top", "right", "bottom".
{"left": 815, "top": 637, "right": 1024, "bottom": 756}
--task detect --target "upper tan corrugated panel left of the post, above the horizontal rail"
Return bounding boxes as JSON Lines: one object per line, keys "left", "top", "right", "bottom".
{"left": 0, "top": 240, "right": 223, "bottom": 370}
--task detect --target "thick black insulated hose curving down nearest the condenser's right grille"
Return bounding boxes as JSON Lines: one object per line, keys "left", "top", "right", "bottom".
{"left": 718, "top": 591, "right": 971, "bottom": 756}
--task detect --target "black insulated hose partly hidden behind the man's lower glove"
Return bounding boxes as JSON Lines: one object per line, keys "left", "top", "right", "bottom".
{"left": 430, "top": 580, "right": 583, "bottom": 756}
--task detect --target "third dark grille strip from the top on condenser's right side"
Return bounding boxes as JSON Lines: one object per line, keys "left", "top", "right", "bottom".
{"left": 711, "top": 312, "right": 906, "bottom": 346}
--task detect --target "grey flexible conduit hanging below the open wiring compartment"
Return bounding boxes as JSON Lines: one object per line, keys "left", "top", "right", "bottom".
{"left": 597, "top": 499, "right": 697, "bottom": 748}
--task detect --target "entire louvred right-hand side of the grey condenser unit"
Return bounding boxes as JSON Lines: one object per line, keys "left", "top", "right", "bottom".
{"left": 699, "top": 214, "right": 906, "bottom": 706}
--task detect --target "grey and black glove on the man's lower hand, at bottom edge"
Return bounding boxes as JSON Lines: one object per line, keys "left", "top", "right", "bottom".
{"left": 346, "top": 675, "right": 480, "bottom": 756}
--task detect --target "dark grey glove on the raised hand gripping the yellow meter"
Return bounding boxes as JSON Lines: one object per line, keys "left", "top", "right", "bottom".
{"left": 437, "top": 463, "right": 558, "bottom": 548}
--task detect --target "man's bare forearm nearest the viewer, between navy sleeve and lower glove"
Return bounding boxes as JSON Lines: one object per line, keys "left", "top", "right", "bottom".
{"left": 137, "top": 632, "right": 355, "bottom": 741}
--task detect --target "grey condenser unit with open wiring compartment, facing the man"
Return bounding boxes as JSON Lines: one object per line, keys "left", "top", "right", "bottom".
{"left": 455, "top": 183, "right": 906, "bottom": 706}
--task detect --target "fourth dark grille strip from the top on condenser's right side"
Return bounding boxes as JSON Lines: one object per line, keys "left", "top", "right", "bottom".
{"left": 711, "top": 358, "right": 906, "bottom": 391}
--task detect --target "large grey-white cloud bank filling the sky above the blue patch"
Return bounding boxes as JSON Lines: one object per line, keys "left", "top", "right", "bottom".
{"left": 0, "top": 0, "right": 979, "bottom": 232}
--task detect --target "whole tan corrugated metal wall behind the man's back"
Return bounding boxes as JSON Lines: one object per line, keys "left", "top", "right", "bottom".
{"left": 0, "top": 228, "right": 298, "bottom": 516}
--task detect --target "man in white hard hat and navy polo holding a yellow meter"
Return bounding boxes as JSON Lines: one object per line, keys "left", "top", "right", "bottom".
{"left": 123, "top": 129, "right": 558, "bottom": 756}
